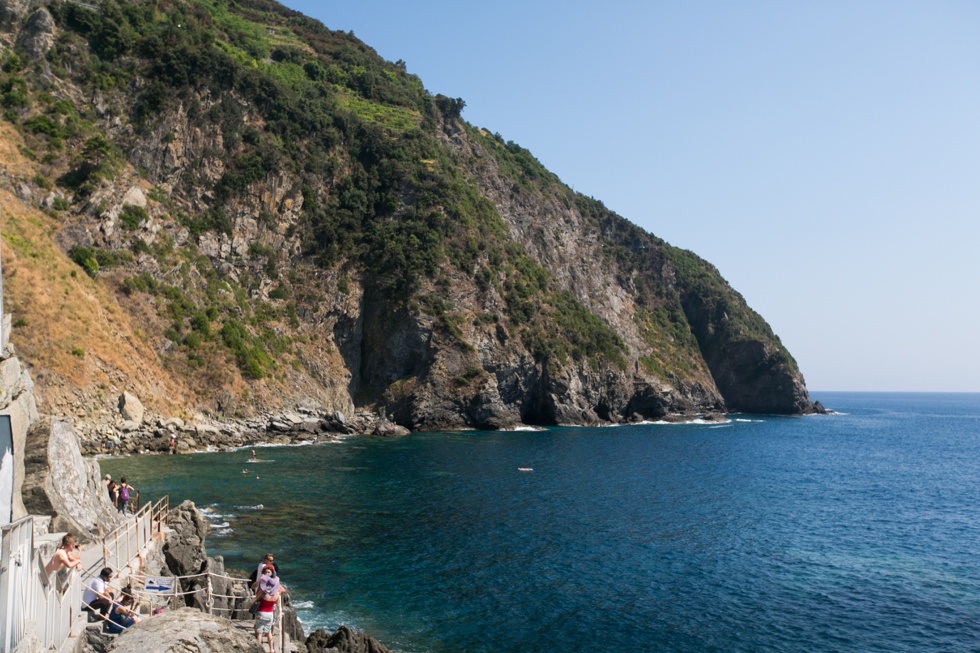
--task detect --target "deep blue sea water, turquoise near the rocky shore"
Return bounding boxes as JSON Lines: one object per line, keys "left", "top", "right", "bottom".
{"left": 102, "top": 393, "right": 980, "bottom": 653}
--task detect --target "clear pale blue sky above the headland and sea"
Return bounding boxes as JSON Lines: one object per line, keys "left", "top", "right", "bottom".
{"left": 285, "top": 0, "right": 980, "bottom": 392}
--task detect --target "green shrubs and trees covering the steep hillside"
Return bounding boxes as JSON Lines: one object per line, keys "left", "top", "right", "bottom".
{"left": 0, "top": 0, "right": 625, "bottom": 378}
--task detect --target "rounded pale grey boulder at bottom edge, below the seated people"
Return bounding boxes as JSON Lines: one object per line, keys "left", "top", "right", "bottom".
{"left": 106, "top": 608, "right": 265, "bottom": 653}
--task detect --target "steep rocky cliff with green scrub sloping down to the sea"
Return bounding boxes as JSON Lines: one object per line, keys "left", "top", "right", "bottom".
{"left": 0, "top": 0, "right": 812, "bottom": 429}
